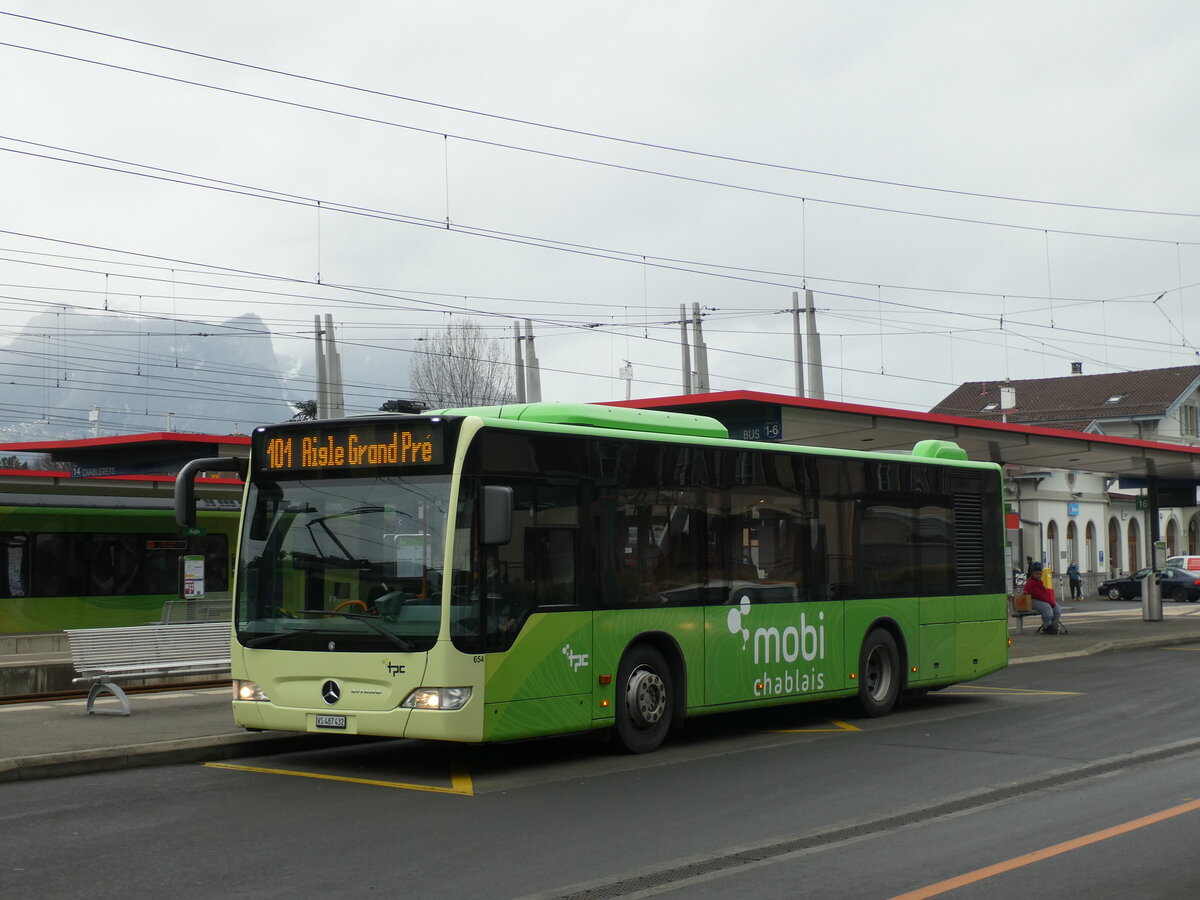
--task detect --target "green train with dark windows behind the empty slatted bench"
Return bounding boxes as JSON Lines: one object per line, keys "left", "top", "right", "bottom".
{"left": 0, "top": 496, "right": 240, "bottom": 635}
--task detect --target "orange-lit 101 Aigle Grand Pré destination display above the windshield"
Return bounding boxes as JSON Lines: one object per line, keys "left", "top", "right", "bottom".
{"left": 254, "top": 422, "right": 445, "bottom": 472}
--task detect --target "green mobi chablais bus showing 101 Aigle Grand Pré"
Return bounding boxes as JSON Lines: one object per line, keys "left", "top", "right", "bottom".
{"left": 176, "top": 403, "right": 1008, "bottom": 752}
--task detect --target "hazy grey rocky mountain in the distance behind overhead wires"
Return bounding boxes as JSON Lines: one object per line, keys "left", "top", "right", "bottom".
{"left": 0, "top": 311, "right": 295, "bottom": 440}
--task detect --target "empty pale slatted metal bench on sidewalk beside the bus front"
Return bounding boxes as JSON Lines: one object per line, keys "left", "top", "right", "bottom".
{"left": 67, "top": 622, "right": 229, "bottom": 715}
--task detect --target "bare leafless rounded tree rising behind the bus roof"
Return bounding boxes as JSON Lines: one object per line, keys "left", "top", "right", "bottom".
{"left": 408, "top": 319, "right": 516, "bottom": 408}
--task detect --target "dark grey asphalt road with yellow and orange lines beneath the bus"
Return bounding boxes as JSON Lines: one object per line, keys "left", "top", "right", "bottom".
{"left": 0, "top": 646, "right": 1200, "bottom": 900}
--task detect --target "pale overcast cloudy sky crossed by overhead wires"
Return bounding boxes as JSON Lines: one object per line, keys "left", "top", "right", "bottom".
{"left": 0, "top": 0, "right": 1200, "bottom": 436}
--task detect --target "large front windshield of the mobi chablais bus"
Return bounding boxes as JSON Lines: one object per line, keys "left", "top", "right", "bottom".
{"left": 236, "top": 475, "right": 450, "bottom": 652}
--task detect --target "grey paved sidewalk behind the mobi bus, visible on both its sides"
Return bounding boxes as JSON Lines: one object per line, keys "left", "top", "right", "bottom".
{"left": 0, "top": 600, "right": 1200, "bottom": 782}
